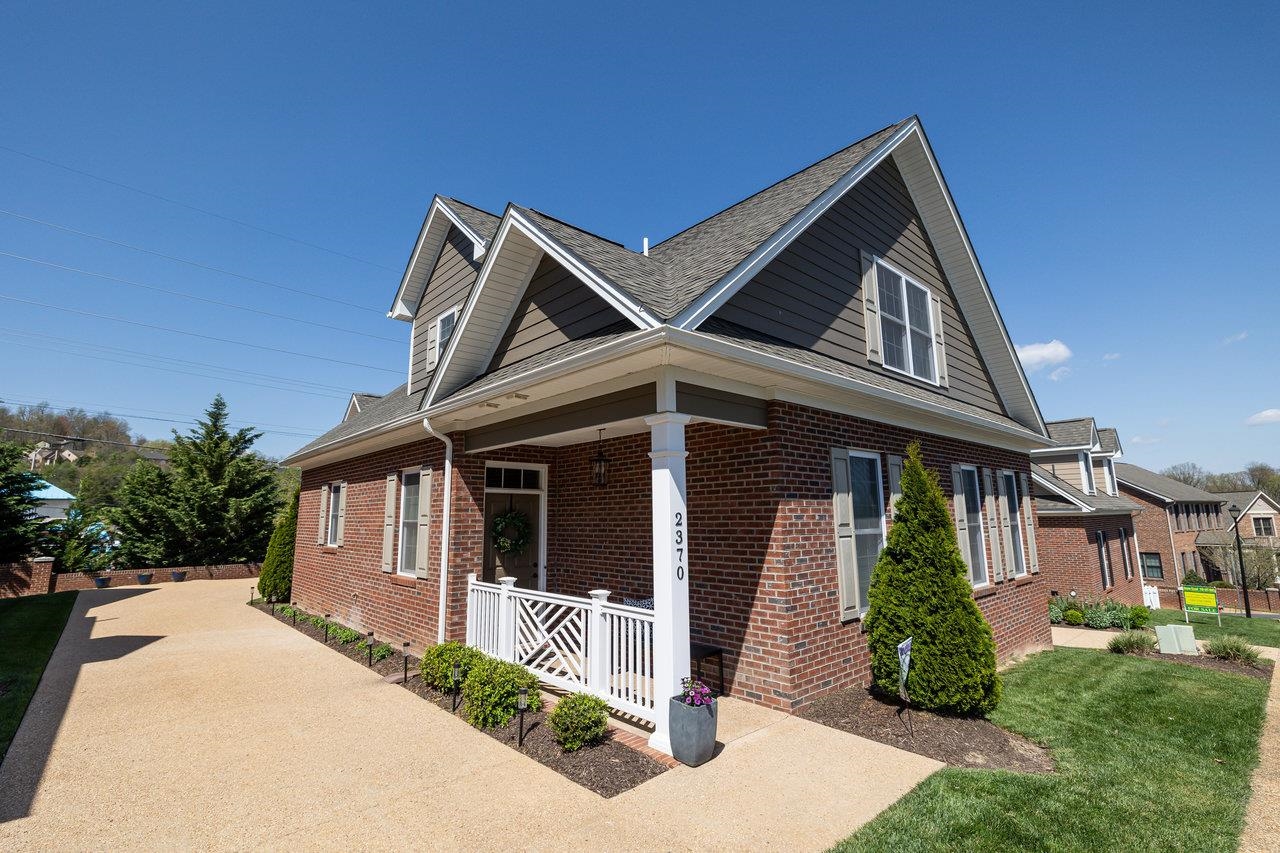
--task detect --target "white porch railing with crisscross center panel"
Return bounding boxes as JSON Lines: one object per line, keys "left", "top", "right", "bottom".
{"left": 467, "top": 574, "right": 654, "bottom": 722}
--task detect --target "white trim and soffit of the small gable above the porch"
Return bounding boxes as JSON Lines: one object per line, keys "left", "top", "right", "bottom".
{"left": 425, "top": 205, "right": 660, "bottom": 407}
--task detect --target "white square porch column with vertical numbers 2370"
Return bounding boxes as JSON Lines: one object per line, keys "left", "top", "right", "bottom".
{"left": 645, "top": 412, "right": 689, "bottom": 756}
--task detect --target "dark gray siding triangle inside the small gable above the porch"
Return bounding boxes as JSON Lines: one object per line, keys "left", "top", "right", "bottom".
{"left": 486, "top": 257, "right": 623, "bottom": 373}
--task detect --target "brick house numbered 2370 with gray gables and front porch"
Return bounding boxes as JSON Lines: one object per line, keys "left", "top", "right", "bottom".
{"left": 287, "top": 117, "right": 1051, "bottom": 749}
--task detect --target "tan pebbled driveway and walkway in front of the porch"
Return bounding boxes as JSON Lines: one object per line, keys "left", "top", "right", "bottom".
{"left": 0, "top": 580, "right": 941, "bottom": 850}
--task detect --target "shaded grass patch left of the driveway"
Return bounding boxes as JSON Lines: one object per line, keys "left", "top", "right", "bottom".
{"left": 0, "top": 592, "right": 76, "bottom": 761}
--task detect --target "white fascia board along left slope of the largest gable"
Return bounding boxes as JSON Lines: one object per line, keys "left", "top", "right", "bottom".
{"left": 671, "top": 118, "right": 918, "bottom": 330}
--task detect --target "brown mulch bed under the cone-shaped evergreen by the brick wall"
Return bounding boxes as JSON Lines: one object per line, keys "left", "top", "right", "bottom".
{"left": 800, "top": 688, "right": 1053, "bottom": 774}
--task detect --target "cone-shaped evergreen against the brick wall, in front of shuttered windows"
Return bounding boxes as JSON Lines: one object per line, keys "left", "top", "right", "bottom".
{"left": 867, "top": 442, "right": 1001, "bottom": 715}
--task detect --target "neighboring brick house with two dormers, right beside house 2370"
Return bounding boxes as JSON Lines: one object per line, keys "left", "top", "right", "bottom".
{"left": 1032, "top": 418, "right": 1152, "bottom": 605}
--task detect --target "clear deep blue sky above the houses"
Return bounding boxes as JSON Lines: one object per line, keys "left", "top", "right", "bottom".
{"left": 0, "top": 3, "right": 1280, "bottom": 470}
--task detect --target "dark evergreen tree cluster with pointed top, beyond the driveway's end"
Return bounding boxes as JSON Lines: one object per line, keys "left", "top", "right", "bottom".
{"left": 108, "top": 394, "right": 283, "bottom": 567}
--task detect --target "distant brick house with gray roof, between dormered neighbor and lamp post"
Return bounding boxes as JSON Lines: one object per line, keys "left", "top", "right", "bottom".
{"left": 1115, "top": 462, "right": 1229, "bottom": 594}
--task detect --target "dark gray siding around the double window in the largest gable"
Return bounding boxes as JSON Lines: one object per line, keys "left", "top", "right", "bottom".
{"left": 716, "top": 159, "right": 1007, "bottom": 415}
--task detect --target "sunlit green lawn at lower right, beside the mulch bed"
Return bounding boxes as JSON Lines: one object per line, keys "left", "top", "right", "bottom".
{"left": 836, "top": 649, "right": 1268, "bottom": 852}
